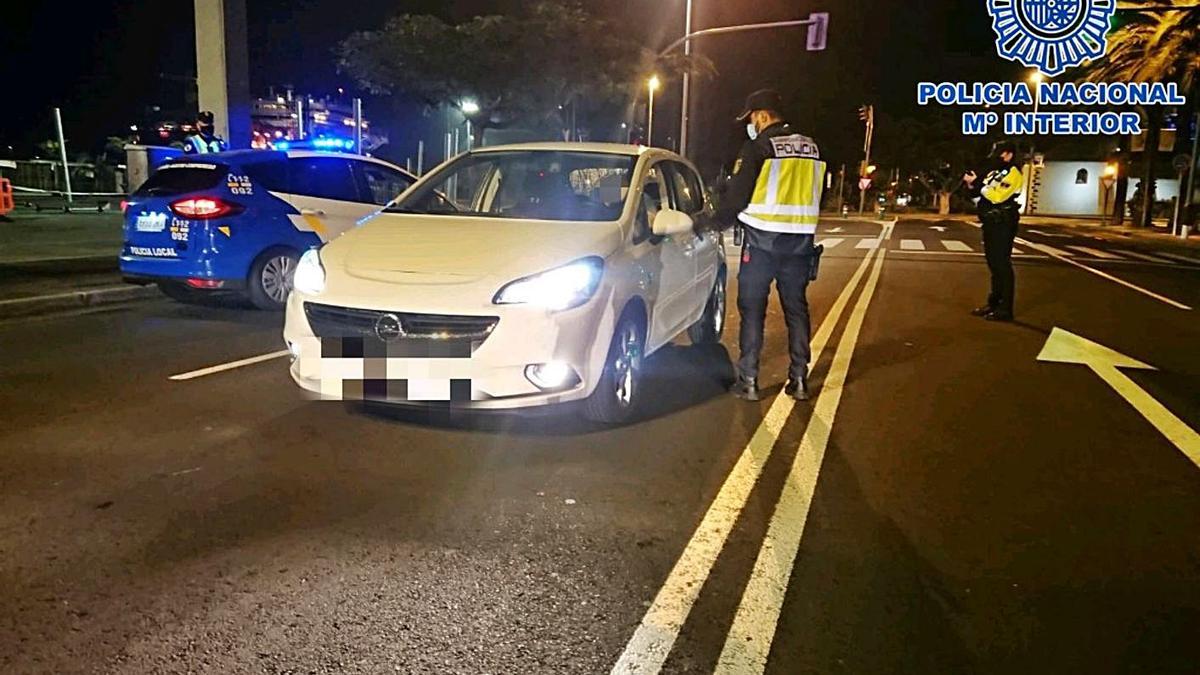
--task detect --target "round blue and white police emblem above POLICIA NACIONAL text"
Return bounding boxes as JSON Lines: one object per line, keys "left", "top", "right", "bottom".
{"left": 988, "top": 0, "right": 1117, "bottom": 76}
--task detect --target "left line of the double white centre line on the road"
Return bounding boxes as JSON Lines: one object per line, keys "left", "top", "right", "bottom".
{"left": 612, "top": 223, "right": 893, "bottom": 675}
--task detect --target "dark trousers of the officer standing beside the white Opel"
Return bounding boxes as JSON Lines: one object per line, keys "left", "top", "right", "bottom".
{"left": 738, "top": 245, "right": 812, "bottom": 380}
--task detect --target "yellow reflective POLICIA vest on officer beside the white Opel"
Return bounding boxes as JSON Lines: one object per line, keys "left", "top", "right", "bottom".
{"left": 738, "top": 133, "right": 826, "bottom": 234}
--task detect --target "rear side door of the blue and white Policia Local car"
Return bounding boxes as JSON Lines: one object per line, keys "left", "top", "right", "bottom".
{"left": 286, "top": 154, "right": 379, "bottom": 241}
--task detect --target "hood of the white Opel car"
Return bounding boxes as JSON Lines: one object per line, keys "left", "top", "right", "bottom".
{"left": 322, "top": 214, "right": 620, "bottom": 285}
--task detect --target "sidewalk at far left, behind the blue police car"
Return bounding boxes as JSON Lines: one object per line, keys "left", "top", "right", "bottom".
{"left": 0, "top": 210, "right": 158, "bottom": 318}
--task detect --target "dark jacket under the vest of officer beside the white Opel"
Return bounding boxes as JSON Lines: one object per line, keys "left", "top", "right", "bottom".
{"left": 715, "top": 121, "right": 812, "bottom": 256}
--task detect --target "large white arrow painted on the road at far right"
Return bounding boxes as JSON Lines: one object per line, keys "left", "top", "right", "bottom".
{"left": 1038, "top": 328, "right": 1200, "bottom": 467}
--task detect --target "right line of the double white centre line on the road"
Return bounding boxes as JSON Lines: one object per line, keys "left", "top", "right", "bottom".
{"left": 713, "top": 239, "right": 887, "bottom": 675}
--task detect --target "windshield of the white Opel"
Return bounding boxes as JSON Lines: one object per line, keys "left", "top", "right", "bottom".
{"left": 388, "top": 150, "right": 637, "bottom": 221}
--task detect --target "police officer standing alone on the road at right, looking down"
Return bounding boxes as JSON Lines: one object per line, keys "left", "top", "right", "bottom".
{"left": 962, "top": 141, "right": 1025, "bottom": 322}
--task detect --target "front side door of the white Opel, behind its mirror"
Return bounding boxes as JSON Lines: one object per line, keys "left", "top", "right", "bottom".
{"left": 634, "top": 162, "right": 696, "bottom": 350}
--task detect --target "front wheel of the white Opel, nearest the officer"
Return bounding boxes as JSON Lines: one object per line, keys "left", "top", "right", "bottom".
{"left": 583, "top": 315, "right": 646, "bottom": 424}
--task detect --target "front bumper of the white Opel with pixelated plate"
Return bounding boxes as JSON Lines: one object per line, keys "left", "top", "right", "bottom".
{"left": 283, "top": 285, "right": 614, "bottom": 410}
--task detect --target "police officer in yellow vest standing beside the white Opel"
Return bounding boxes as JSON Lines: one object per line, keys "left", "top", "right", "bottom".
{"left": 715, "top": 89, "right": 826, "bottom": 401}
